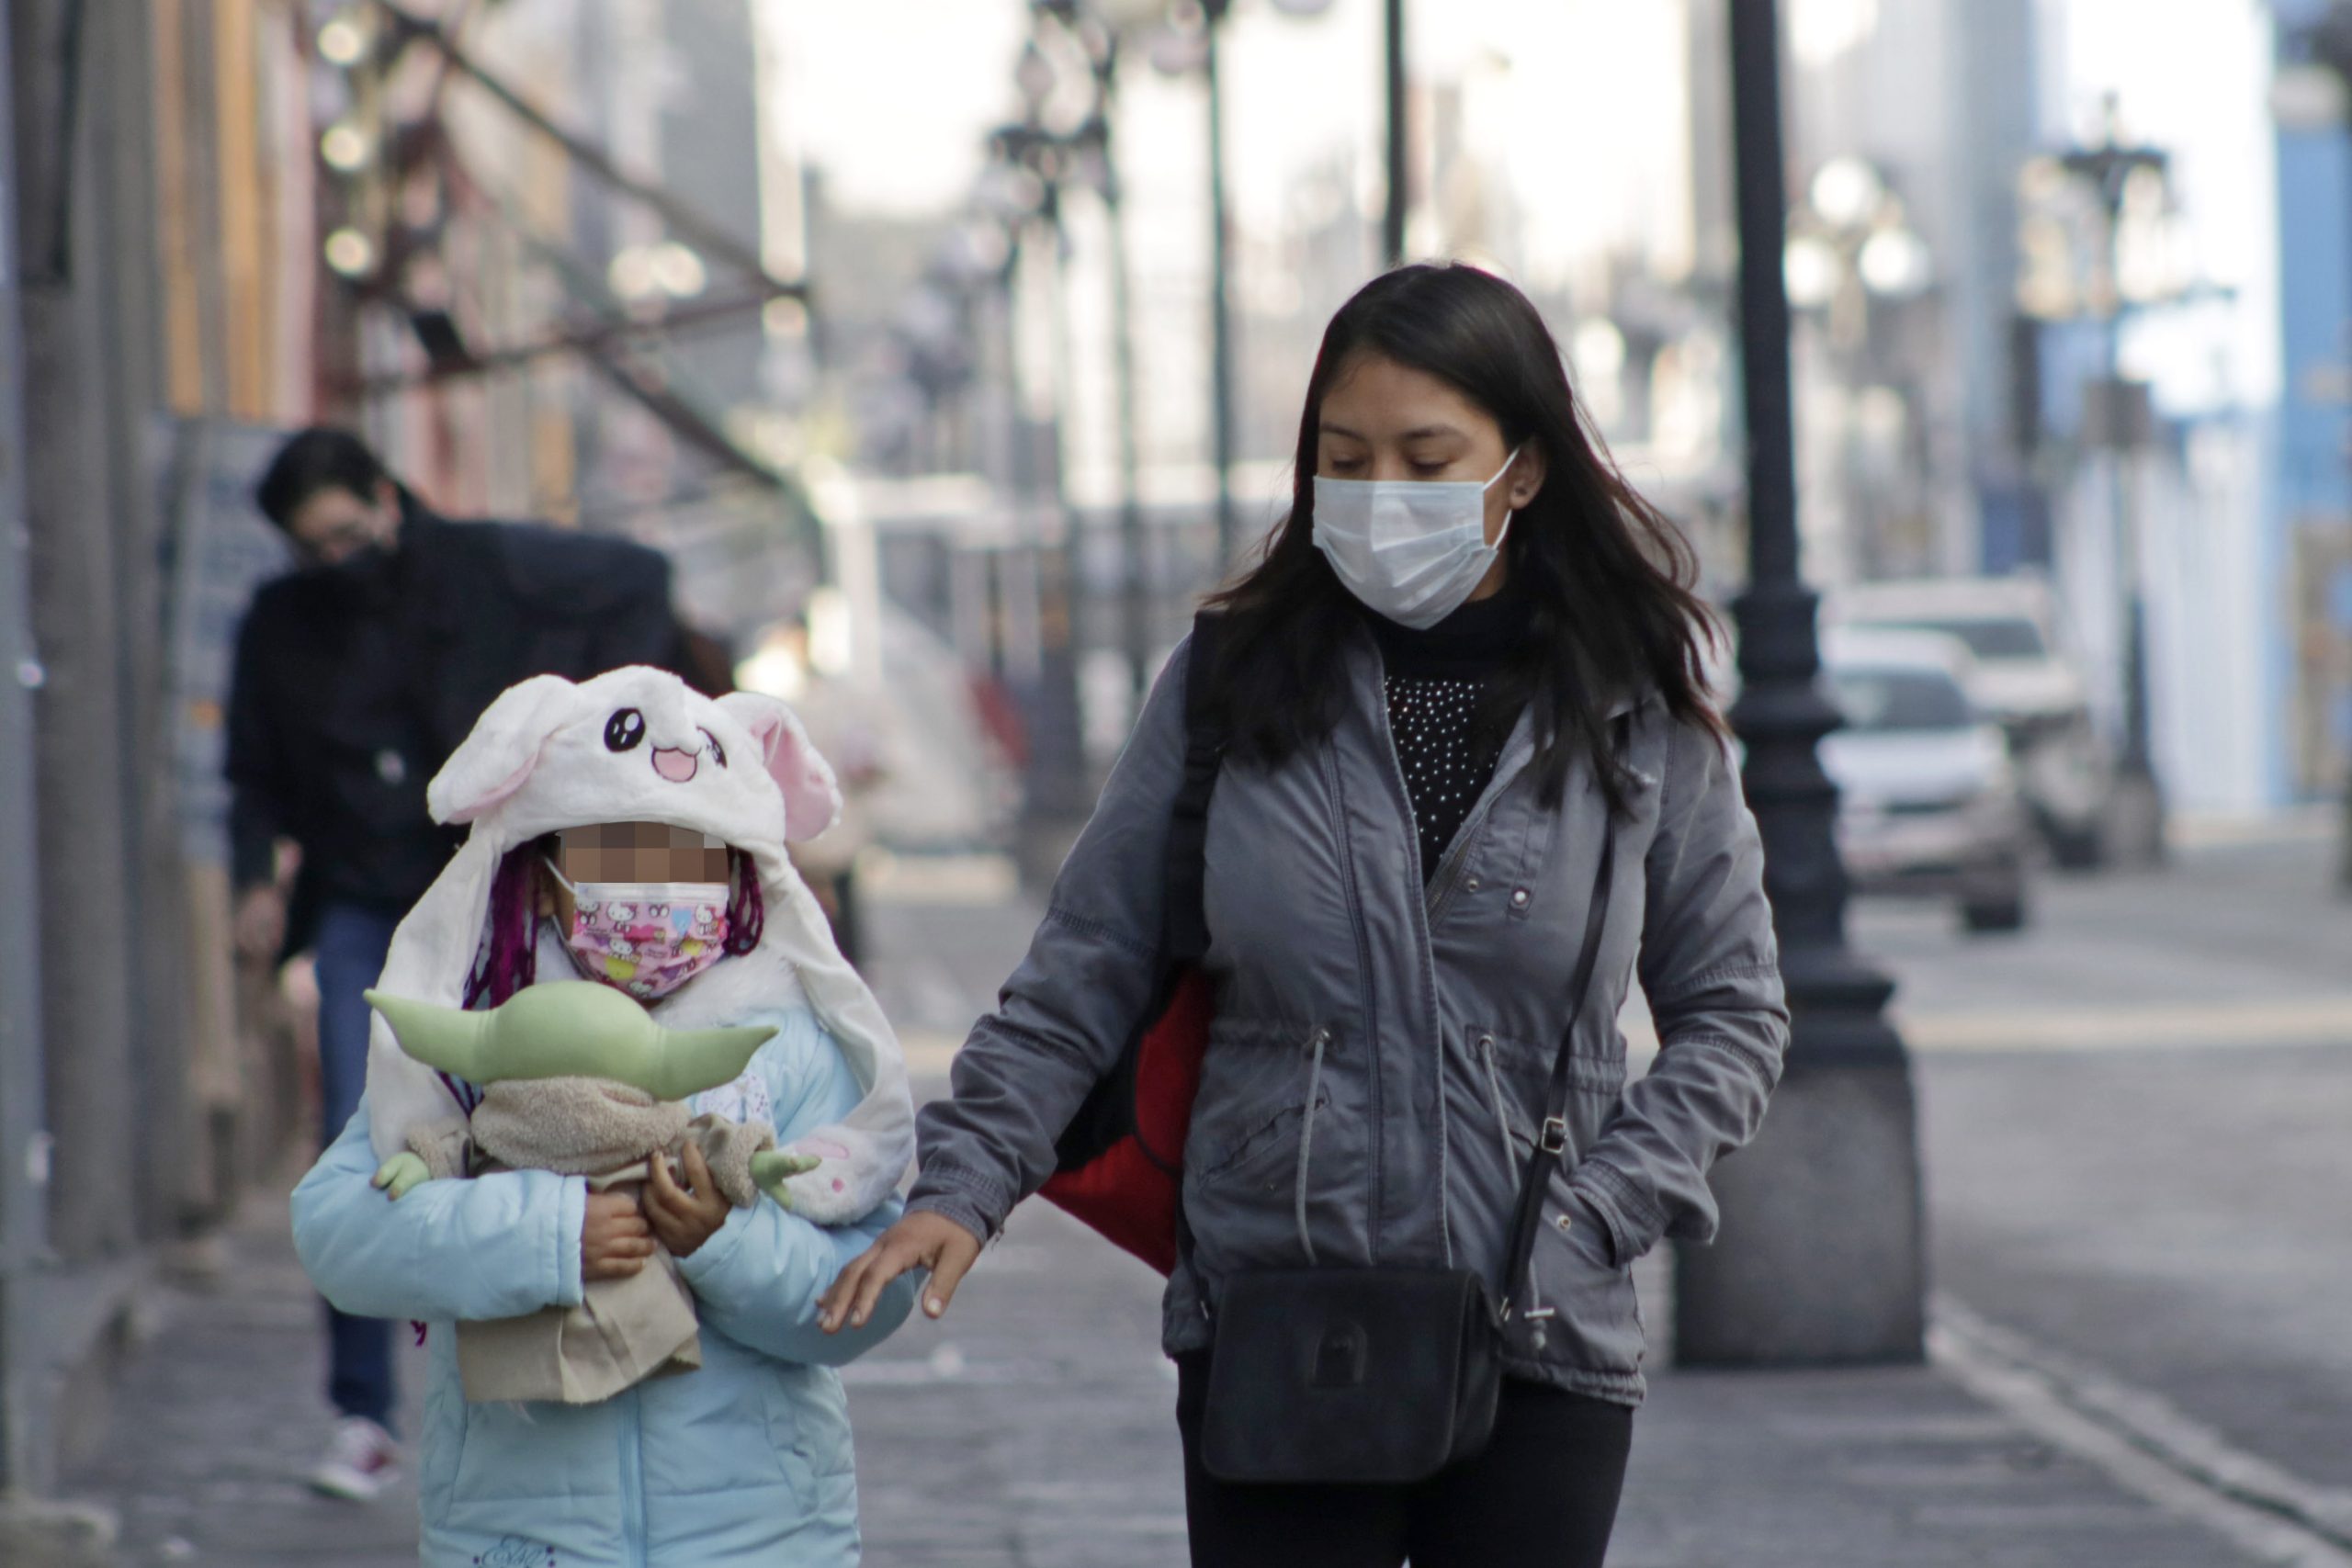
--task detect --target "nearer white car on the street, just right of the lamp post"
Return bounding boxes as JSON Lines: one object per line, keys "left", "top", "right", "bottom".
{"left": 1820, "top": 630, "right": 2034, "bottom": 931}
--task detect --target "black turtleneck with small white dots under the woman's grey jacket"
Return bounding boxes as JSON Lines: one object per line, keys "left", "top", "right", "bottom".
{"left": 1364, "top": 581, "right": 1532, "bottom": 882}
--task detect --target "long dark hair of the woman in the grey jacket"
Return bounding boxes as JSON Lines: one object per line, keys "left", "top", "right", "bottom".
{"left": 1209, "top": 265, "right": 1722, "bottom": 811}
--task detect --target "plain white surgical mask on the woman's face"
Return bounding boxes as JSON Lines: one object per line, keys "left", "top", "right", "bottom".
{"left": 1315, "top": 446, "right": 1524, "bottom": 630}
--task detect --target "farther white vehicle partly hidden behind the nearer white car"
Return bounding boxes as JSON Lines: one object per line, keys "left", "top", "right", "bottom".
{"left": 1823, "top": 576, "right": 2114, "bottom": 867}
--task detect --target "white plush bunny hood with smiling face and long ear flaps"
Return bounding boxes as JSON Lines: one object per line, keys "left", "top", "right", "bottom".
{"left": 367, "top": 668, "right": 915, "bottom": 1224}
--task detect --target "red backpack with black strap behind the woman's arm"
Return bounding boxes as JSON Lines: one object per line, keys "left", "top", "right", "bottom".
{"left": 1042, "top": 616, "right": 1226, "bottom": 1274}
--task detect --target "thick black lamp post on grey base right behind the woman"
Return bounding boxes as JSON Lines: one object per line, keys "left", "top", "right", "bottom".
{"left": 1675, "top": 0, "right": 1927, "bottom": 1366}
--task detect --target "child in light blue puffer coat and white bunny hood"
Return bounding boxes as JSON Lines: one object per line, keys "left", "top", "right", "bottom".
{"left": 294, "top": 670, "right": 910, "bottom": 1565}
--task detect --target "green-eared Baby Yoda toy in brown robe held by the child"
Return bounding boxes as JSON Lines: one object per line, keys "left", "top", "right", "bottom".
{"left": 367, "top": 980, "right": 820, "bottom": 1404}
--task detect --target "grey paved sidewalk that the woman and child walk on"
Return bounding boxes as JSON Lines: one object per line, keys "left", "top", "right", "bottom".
{"left": 28, "top": 879, "right": 2322, "bottom": 1568}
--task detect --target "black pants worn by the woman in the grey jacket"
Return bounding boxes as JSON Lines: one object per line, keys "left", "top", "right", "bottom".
{"left": 1176, "top": 1354, "right": 1633, "bottom": 1568}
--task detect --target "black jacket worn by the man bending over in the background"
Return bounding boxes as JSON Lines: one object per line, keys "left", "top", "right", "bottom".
{"left": 228, "top": 501, "right": 684, "bottom": 952}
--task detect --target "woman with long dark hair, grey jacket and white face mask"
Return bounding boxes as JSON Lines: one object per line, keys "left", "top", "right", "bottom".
{"left": 826, "top": 265, "right": 1788, "bottom": 1568}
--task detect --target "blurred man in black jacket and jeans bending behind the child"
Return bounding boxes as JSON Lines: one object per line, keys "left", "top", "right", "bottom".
{"left": 228, "top": 428, "right": 684, "bottom": 1500}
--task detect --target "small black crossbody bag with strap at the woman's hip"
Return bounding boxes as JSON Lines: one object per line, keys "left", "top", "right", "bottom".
{"left": 1179, "top": 823, "right": 1616, "bottom": 1483}
